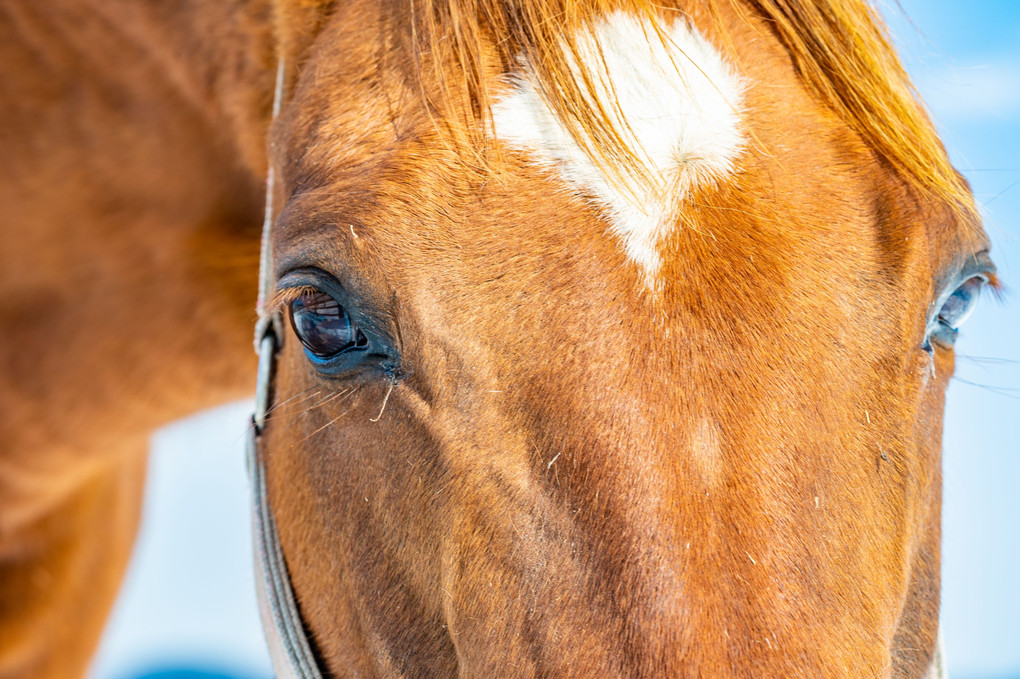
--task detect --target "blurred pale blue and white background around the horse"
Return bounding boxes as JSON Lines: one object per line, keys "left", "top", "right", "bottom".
{"left": 92, "top": 0, "right": 1020, "bottom": 679}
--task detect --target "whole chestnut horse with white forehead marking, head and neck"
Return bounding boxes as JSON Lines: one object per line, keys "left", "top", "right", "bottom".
{"left": 0, "top": 0, "right": 998, "bottom": 678}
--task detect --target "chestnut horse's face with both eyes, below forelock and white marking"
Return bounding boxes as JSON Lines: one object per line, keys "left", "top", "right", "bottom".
{"left": 259, "top": 3, "right": 990, "bottom": 677}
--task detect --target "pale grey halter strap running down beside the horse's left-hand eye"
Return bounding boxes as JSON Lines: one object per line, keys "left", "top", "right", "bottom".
{"left": 245, "top": 58, "right": 322, "bottom": 679}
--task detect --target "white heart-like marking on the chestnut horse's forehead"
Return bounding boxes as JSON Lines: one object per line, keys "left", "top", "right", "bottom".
{"left": 493, "top": 11, "right": 744, "bottom": 288}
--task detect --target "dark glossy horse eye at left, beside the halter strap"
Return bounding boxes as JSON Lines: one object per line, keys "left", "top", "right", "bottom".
{"left": 291, "top": 291, "right": 368, "bottom": 359}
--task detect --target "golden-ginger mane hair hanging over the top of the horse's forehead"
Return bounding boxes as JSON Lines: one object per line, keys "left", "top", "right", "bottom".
{"left": 403, "top": 0, "right": 977, "bottom": 223}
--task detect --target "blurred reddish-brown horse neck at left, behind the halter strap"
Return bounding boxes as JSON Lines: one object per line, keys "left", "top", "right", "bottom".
{"left": 0, "top": 0, "right": 275, "bottom": 504}
